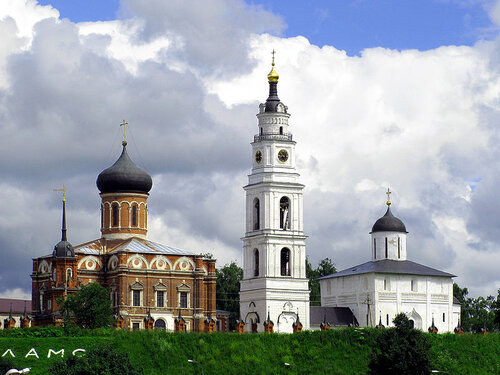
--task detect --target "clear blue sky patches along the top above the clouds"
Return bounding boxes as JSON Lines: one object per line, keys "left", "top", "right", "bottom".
{"left": 39, "top": 0, "right": 497, "bottom": 56}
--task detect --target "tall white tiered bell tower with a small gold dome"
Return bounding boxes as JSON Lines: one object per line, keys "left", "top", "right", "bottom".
{"left": 240, "top": 51, "right": 309, "bottom": 333}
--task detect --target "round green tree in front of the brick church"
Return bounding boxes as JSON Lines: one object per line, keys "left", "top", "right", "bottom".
{"left": 59, "top": 283, "right": 113, "bottom": 329}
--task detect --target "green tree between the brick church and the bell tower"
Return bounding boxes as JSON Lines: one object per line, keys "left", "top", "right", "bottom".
{"left": 215, "top": 261, "right": 243, "bottom": 329}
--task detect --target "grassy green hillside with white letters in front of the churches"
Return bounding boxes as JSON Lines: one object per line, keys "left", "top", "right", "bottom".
{"left": 0, "top": 328, "right": 500, "bottom": 375}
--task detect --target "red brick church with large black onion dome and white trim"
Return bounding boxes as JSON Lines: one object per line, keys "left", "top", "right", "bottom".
{"left": 31, "top": 136, "right": 216, "bottom": 332}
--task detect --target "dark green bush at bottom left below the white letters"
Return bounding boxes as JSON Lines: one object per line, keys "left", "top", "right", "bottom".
{"left": 49, "top": 345, "right": 142, "bottom": 375}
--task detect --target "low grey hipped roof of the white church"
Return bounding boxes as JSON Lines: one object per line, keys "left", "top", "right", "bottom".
{"left": 319, "top": 259, "right": 456, "bottom": 280}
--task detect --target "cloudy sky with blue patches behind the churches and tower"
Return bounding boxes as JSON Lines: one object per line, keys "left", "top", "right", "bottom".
{"left": 0, "top": 0, "right": 500, "bottom": 298}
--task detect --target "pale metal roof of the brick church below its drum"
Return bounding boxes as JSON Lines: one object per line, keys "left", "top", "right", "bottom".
{"left": 75, "top": 237, "right": 195, "bottom": 255}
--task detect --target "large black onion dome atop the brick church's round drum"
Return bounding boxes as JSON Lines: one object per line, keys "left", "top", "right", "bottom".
{"left": 96, "top": 143, "right": 153, "bottom": 194}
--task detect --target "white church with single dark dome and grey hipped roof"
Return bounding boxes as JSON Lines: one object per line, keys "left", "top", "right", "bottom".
{"left": 320, "top": 195, "right": 460, "bottom": 332}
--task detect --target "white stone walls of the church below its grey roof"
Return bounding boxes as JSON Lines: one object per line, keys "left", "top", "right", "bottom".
{"left": 320, "top": 273, "right": 460, "bottom": 333}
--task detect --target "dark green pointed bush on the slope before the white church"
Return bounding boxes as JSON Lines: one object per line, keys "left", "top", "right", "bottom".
{"left": 370, "top": 313, "right": 431, "bottom": 375}
